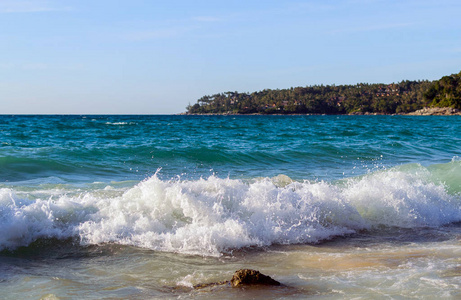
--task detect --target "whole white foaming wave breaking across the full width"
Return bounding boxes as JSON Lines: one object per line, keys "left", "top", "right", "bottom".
{"left": 0, "top": 159, "right": 461, "bottom": 256}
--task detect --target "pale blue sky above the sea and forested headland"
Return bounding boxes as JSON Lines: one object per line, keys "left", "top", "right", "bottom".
{"left": 0, "top": 0, "right": 461, "bottom": 114}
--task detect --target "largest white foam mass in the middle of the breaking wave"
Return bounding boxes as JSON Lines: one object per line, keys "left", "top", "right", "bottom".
{"left": 79, "top": 176, "right": 362, "bottom": 255}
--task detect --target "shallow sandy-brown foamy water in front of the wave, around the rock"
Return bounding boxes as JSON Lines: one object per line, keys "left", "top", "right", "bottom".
{"left": 0, "top": 229, "right": 461, "bottom": 299}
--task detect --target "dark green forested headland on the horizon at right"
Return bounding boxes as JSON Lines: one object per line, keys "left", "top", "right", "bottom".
{"left": 187, "top": 72, "right": 461, "bottom": 114}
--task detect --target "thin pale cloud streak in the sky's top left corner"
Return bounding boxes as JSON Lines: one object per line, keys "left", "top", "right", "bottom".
{"left": 0, "top": 0, "right": 71, "bottom": 13}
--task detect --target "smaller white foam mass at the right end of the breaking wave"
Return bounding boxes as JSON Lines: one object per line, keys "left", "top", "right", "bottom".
{"left": 344, "top": 164, "right": 461, "bottom": 228}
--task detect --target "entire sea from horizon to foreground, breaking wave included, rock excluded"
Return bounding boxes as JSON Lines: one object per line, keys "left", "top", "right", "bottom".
{"left": 0, "top": 115, "right": 461, "bottom": 299}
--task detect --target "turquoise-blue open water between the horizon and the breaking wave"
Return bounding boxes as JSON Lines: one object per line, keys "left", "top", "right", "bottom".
{"left": 0, "top": 116, "right": 461, "bottom": 184}
